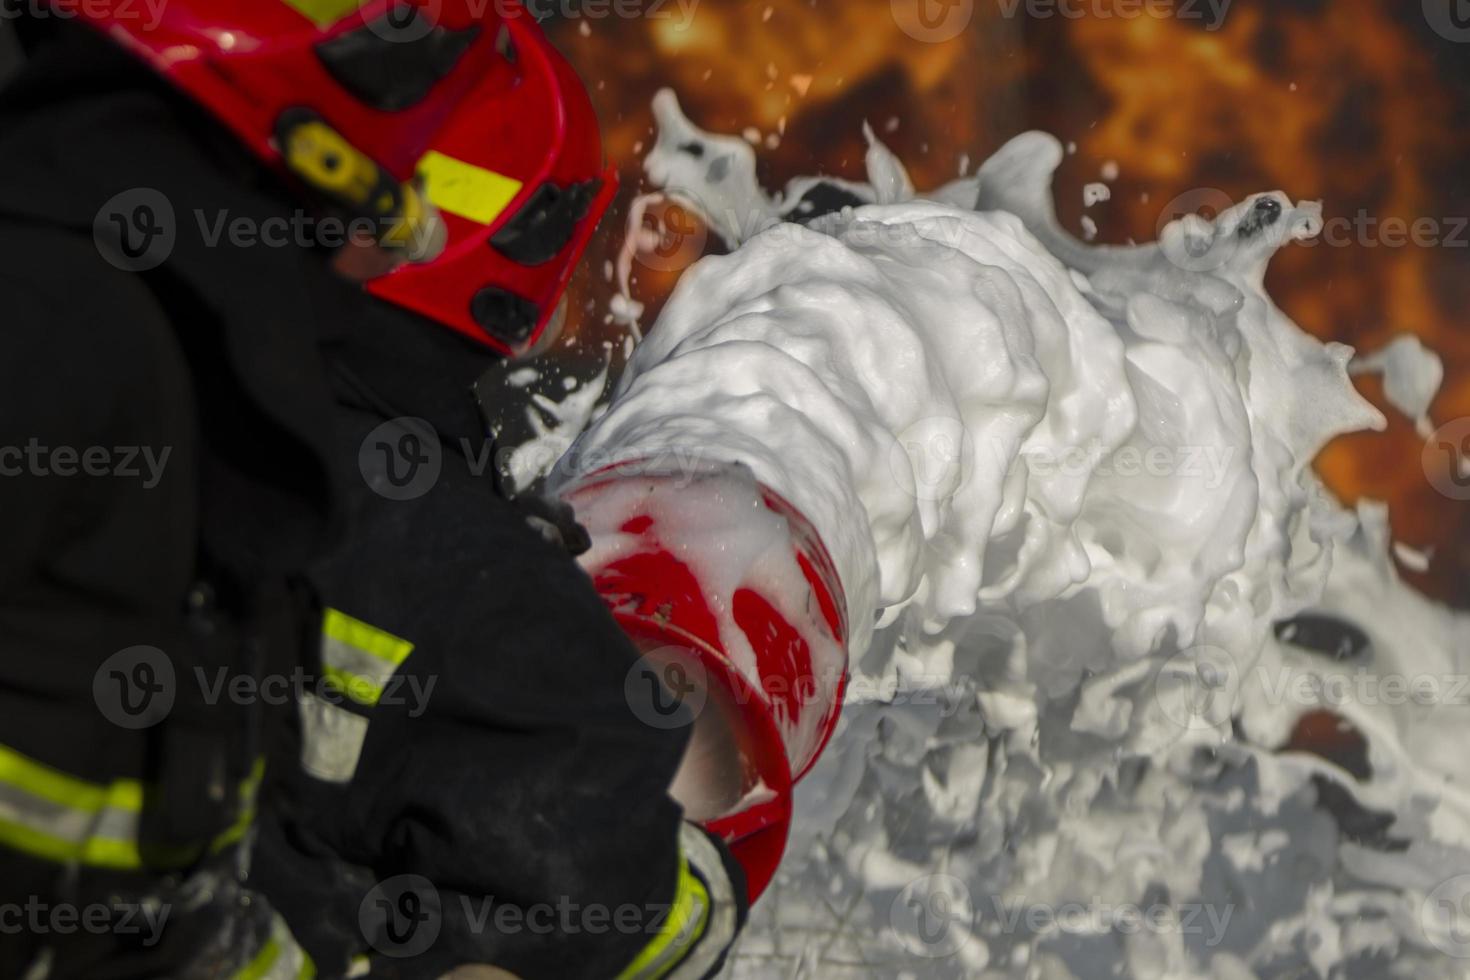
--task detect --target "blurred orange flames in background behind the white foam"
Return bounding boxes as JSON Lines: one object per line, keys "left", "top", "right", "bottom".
{"left": 553, "top": 0, "right": 1470, "bottom": 605}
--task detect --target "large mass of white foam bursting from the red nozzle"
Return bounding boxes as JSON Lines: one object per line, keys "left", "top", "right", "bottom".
{"left": 540, "top": 93, "right": 1470, "bottom": 980}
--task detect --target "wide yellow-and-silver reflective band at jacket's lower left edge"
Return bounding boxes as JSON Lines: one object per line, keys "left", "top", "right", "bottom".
{"left": 0, "top": 745, "right": 265, "bottom": 870}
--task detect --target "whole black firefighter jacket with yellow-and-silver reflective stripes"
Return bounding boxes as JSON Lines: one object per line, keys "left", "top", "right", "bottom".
{"left": 0, "top": 15, "right": 742, "bottom": 980}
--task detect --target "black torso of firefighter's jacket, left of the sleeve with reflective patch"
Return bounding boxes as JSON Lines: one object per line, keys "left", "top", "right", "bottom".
{"left": 0, "top": 15, "right": 340, "bottom": 979}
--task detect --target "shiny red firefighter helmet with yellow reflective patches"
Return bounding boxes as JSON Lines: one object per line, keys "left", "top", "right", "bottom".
{"left": 67, "top": 0, "right": 616, "bottom": 353}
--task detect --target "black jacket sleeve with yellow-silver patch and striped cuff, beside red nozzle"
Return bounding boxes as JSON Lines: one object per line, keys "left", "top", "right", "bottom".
{"left": 257, "top": 276, "right": 744, "bottom": 980}
